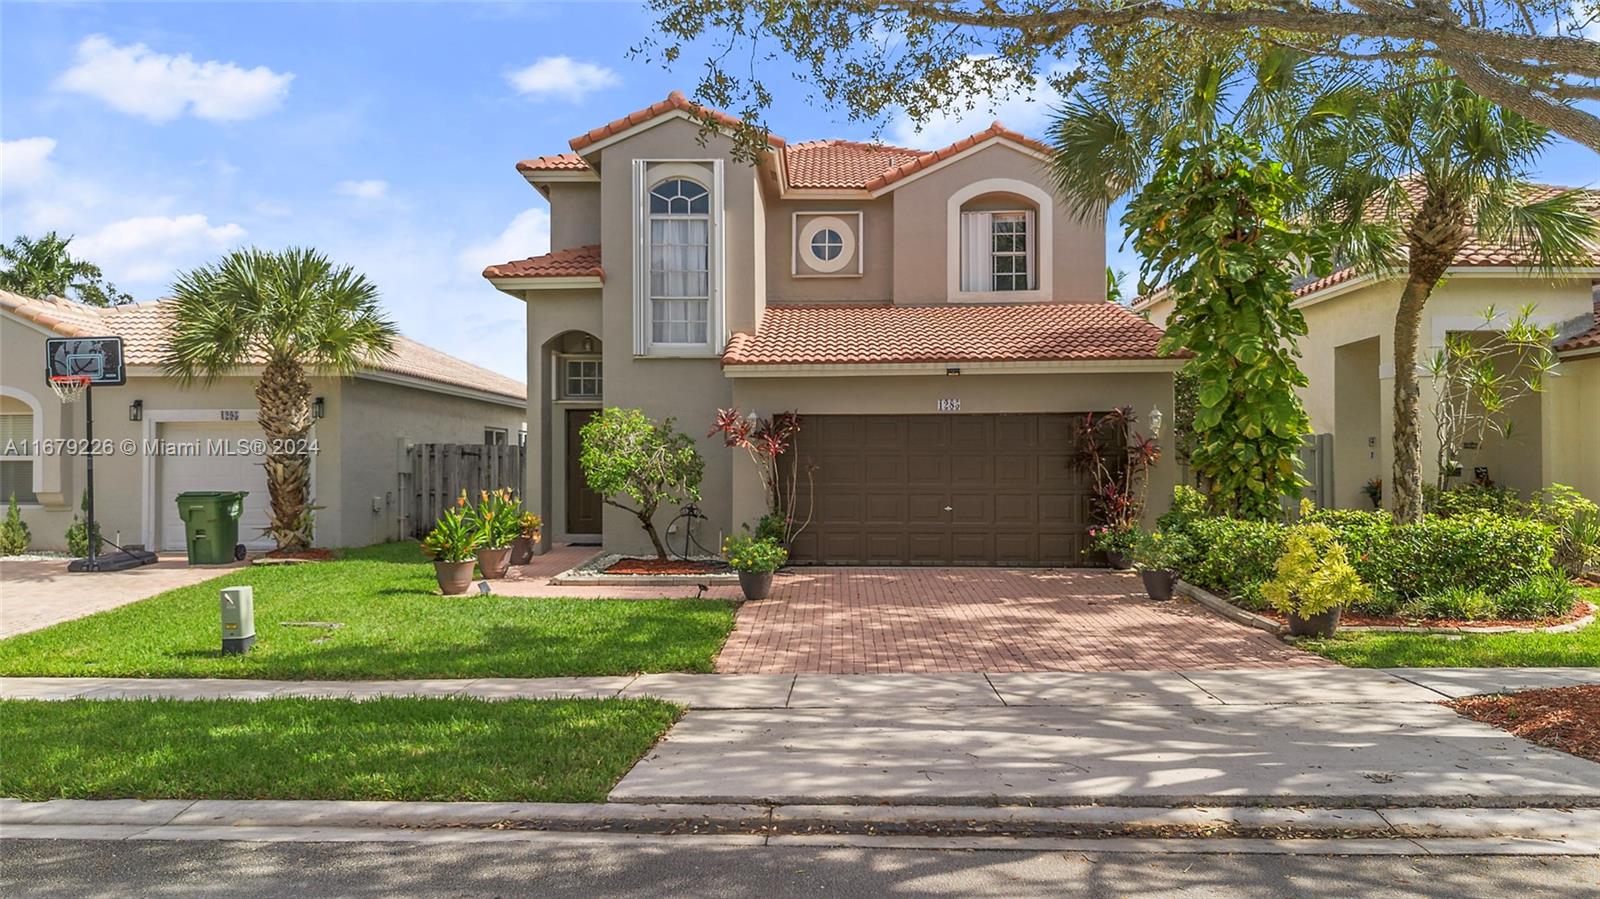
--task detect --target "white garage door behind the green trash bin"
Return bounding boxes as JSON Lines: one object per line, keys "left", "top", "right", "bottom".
{"left": 157, "top": 421, "right": 274, "bottom": 552}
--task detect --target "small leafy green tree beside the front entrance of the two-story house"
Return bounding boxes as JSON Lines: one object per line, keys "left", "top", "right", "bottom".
{"left": 578, "top": 408, "right": 706, "bottom": 560}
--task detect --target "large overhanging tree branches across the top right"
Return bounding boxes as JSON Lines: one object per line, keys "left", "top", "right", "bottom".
{"left": 637, "top": 0, "right": 1600, "bottom": 150}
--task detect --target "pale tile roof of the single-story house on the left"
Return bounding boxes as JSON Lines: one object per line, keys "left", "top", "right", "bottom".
{"left": 0, "top": 291, "right": 528, "bottom": 400}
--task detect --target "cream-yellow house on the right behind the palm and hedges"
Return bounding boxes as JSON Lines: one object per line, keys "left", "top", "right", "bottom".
{"left": 1134, "top": 193, "right": 1600, "bottom": 509}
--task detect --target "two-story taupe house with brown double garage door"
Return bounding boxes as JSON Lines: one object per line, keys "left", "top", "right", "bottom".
{"left": 485, "top": 93, "right": 1176, "bottom": 565}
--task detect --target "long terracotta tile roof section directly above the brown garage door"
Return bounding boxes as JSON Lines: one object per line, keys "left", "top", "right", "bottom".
{"left": 722, "top": 302, "right": 1162, "bottom": 365}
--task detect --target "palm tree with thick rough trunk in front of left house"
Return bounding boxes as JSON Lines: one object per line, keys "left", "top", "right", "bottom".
{"left": 162, "top": 248, "right": 397, "bottom": 552}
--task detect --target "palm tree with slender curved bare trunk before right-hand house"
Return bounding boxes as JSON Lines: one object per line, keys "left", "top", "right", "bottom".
{"left": 1322, "top": 69, "right": 1597, "bottom": 521}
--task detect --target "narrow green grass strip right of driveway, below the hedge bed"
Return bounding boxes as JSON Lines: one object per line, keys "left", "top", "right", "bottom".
{"left": 1299, "top": 589, "right": 1600, "bottom": 669}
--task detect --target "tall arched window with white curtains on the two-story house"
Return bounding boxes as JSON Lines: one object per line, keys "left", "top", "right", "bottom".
{"left": 650, "top": 178, "right": 710, "bottom": 344}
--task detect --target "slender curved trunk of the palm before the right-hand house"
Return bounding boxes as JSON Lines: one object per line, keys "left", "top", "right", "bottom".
{"left": 1394, "top": 186, "right": 1469, "bottom": 523}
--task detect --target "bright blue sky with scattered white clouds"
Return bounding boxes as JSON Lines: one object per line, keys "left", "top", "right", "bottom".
{"left": 0, "top": 2, "right": 1600, "bottom": 378}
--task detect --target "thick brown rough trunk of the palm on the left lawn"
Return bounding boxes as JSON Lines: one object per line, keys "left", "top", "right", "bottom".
{"left": 256, "top": 358, "right": 312, "bottom": 552}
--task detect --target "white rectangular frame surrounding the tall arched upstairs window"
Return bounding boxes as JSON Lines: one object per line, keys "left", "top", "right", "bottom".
{"left": 634, "top": 158, "right": 728, "bottom": 358}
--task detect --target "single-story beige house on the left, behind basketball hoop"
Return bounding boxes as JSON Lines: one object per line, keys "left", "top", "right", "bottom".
{"left": 0, "top": 291, "right": 526, "bottom": 550}
